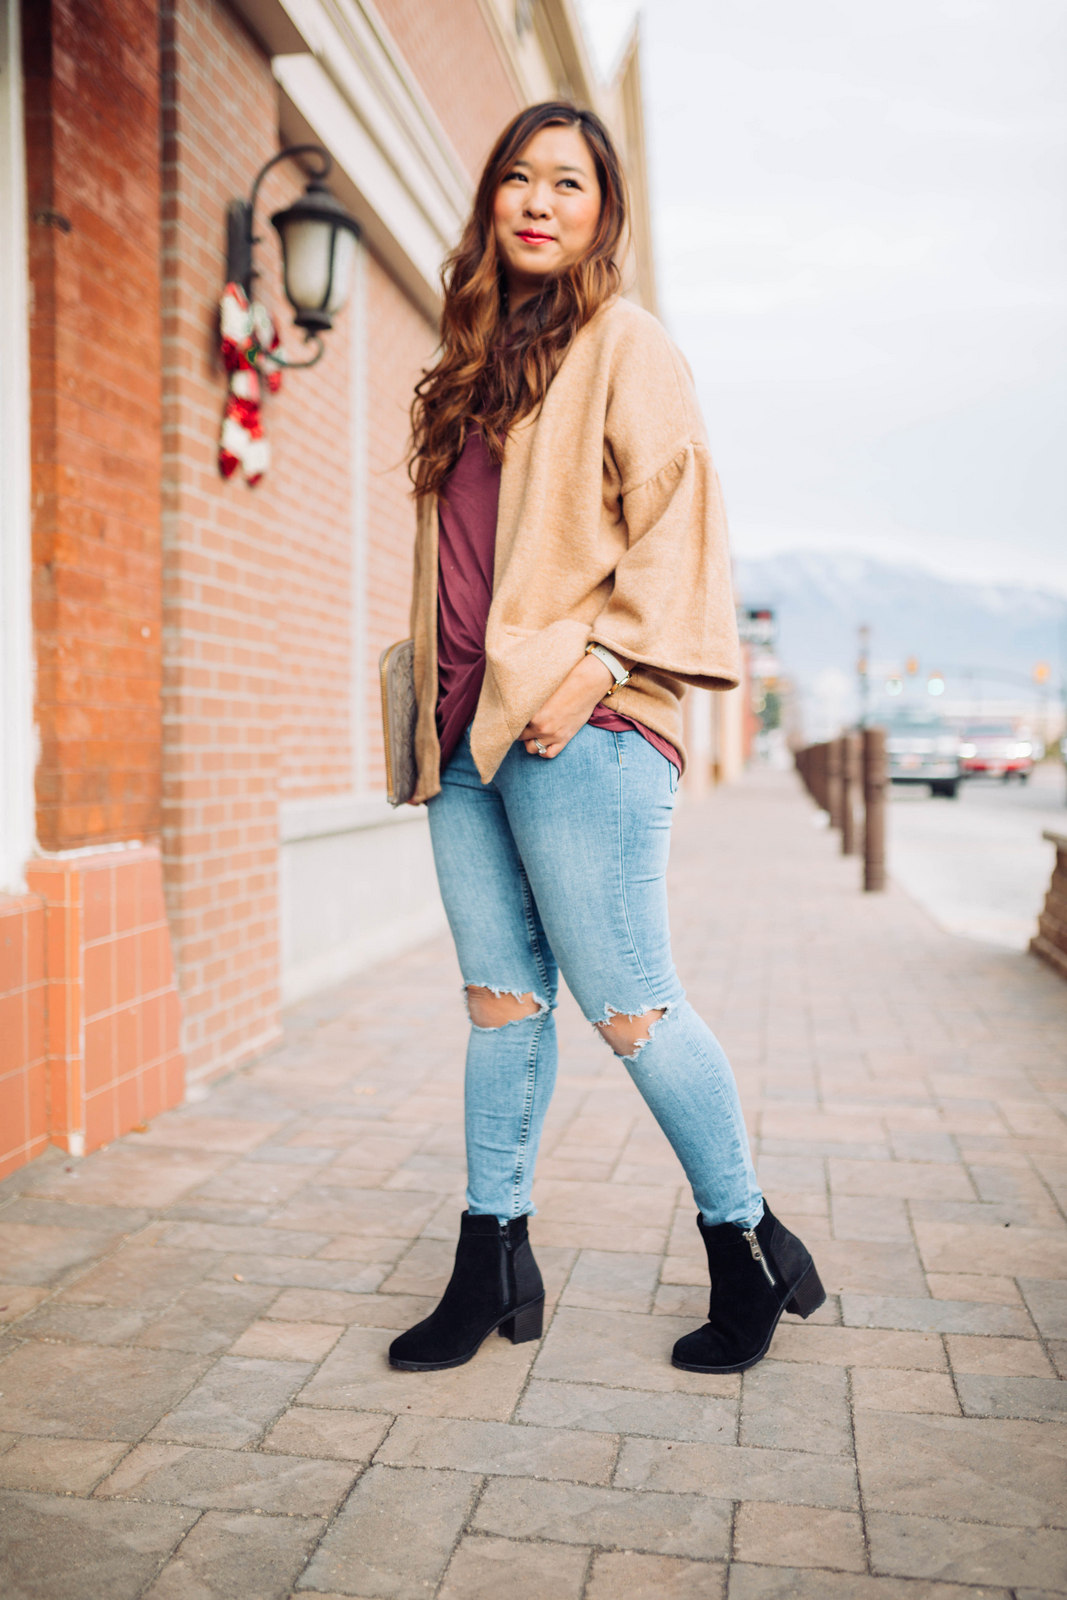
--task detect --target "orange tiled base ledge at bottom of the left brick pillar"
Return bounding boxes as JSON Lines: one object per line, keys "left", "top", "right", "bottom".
{"left": 0, "top": 845, "right": 186, "bottom": 1176}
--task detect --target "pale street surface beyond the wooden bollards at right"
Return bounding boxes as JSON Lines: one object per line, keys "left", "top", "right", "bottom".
{"left": 888, "top": 762, "right": 1067, "bottom": 950}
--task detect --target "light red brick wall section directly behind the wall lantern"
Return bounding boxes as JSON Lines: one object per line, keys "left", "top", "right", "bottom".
{"left": 163, "top": 0, "right": 374, "bottom": 1074}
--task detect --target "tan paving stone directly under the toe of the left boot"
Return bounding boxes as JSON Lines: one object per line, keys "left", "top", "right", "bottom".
{"left": 301, "top": 1328, "right": 537, "bottom": 1422}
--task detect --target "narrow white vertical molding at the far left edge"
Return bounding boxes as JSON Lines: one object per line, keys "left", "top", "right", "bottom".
{"left": 0, "top": 0, "right": 37, "bottom": 894}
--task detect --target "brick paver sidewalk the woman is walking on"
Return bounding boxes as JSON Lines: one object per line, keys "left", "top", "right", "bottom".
{"left": 0, "top": 774, "right": 1067, "bottom": 1600}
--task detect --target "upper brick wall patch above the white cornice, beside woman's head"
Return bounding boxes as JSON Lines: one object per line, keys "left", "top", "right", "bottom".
{"left": 378, "top": 0, "right": 522, "bottom": 178}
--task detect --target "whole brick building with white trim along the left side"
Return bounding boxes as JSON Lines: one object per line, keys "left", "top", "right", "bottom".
{"left": 0, "top": 0, "right": 684, "bottom": 1176}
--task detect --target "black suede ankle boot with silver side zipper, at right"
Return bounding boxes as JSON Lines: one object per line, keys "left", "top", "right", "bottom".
{"left": 672, "top": 1205, "right": 825, "bottom": 1373}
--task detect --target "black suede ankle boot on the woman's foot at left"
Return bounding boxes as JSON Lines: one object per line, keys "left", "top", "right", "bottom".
{"left": 389, "top": 1211, "right": 544, "bottom": 1373}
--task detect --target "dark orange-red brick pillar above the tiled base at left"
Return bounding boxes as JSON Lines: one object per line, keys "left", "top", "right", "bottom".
{"left": 22, "top": 0, "right": 160, "bottom": 850}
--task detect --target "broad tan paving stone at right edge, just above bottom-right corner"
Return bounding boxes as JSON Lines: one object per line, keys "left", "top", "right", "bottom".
{"left": 856, "top": 1414, "right": 1067, "bottom": 1523}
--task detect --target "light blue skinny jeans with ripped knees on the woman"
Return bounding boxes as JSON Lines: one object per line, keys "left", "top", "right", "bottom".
{"left": 429, "top": 725, "right": 763, "bottom": 1227}
